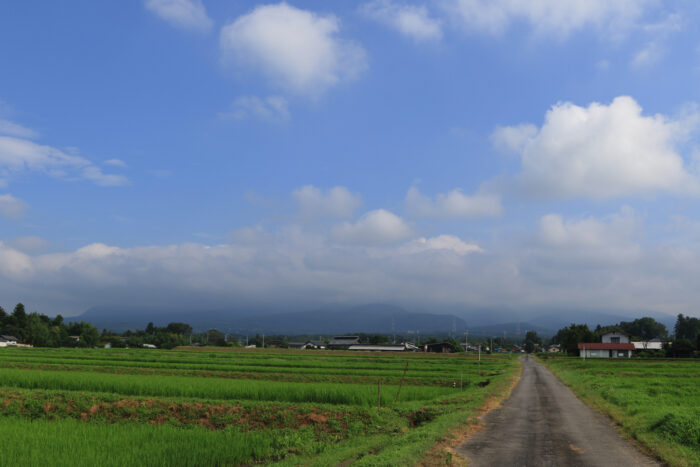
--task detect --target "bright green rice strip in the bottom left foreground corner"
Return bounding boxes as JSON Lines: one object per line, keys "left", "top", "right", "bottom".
{"left": 0, "top": 417, "right": 325, "bottom": 467}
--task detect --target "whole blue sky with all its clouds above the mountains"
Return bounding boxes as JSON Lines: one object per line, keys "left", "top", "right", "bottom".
{"left": 0, "top": 0, "right": 700, "bottom": 316}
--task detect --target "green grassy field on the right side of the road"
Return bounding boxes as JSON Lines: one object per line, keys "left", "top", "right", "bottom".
{"left": 544, "top": 357, "right": 700, "bottom": 466}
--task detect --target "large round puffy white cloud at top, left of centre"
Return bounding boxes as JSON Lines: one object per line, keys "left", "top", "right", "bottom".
{"left": 220, "top": 3, "right": 367, "bottom": 95}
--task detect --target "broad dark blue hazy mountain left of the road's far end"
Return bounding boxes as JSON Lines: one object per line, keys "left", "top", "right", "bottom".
{"left": 70, "top": 304, "right": 466, "bottom": 335}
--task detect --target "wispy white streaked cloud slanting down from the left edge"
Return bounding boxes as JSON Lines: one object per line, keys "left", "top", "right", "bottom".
{"left": 0, "top": 136, "right": 128, "bottom": 186}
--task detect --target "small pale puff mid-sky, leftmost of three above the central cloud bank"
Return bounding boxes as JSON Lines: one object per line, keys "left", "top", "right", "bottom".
{"left": 292, "top": 185, "right": 362, "bottom": 218}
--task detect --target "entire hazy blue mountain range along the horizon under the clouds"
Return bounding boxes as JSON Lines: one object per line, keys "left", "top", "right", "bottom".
{"left": 69, "top": 304, "right": 675, "bottom": 338}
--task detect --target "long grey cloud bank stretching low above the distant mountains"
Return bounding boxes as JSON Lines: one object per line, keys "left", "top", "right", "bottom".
{"left": 0, "top": 208, "right": 700, "bottom": 314}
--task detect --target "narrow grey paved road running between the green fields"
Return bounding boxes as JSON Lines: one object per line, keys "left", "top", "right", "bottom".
{"left": 457, "top": 356, "right": 660, "bottom": 467}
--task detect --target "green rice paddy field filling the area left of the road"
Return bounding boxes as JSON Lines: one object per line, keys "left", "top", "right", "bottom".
{"left": 0, "top": 348, "right": 519, "bottom": 466}
